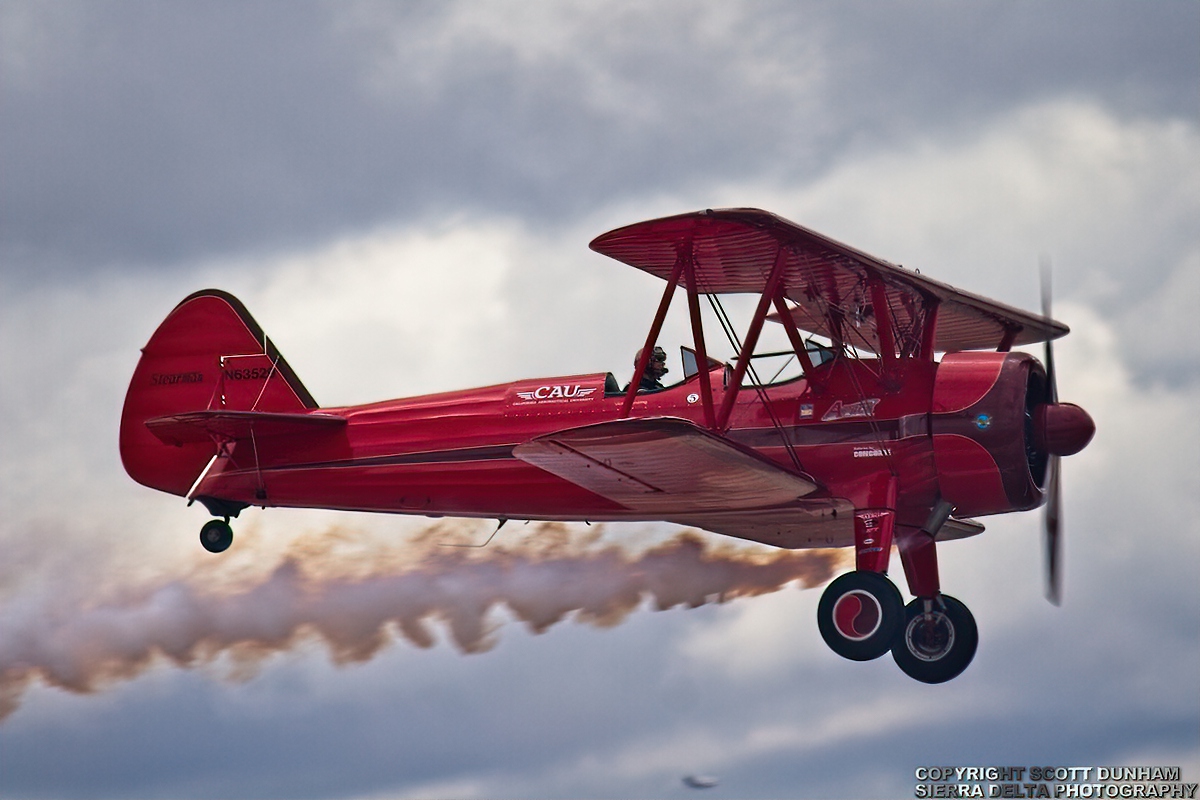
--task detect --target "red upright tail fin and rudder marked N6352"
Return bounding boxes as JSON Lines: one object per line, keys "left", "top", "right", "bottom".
{"left": 120, "top": 289, "right": 317, "bottom": 497}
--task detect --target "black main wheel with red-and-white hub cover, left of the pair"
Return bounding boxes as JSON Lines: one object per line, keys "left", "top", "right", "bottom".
{"left": 817, "top": 572, "right": 904, "bottom": 661}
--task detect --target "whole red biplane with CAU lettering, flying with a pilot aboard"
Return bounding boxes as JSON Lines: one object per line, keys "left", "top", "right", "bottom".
{"left": 120, "top": 209, "right": 1094, "bottom": 682}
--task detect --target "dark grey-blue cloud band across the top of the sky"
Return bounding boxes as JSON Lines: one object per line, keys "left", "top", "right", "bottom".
{"left": 0, "top": 2, "right": 1198, "bottom": 278}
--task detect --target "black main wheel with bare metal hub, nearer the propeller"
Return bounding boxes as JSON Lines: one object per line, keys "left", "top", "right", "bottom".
{"left": 892, "top": 595, "right": 979, "bottom": 684}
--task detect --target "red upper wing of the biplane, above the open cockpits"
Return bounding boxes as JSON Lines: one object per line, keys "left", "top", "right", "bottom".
{"left": 590, "top": 209, "right": 1069, "bottom": 351}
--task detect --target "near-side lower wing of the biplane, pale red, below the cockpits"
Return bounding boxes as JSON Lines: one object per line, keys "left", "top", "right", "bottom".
{"left": 512, "top": 417, "right": 817, "bottom": 512}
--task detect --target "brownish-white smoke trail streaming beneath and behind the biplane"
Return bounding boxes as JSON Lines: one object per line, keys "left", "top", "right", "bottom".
{"left": 0, "top": 522, "right": 841, "bottom": 720}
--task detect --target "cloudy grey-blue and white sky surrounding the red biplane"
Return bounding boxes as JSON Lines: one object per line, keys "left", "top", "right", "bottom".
{"left": 0, "top": 0, "right": 1200, "bottom": 799}
